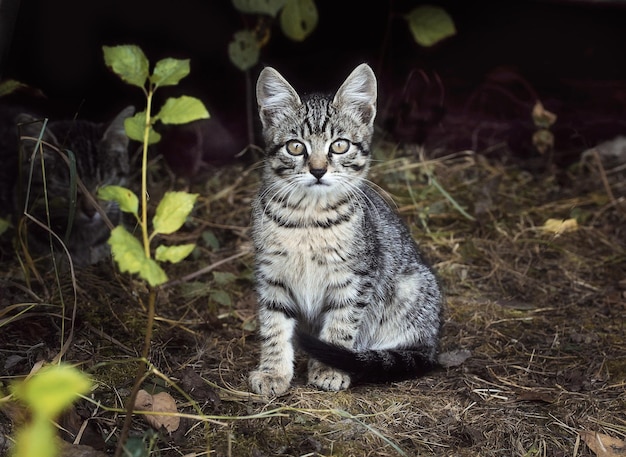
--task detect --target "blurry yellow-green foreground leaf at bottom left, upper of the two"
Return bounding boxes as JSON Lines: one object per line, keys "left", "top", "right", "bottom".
{"left": 15, "top": 365, "right": 91, "bottom": 419}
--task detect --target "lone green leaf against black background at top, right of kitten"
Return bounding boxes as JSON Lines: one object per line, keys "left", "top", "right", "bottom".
{"left": 406, "top": 5, "right": 456, "bottom": 47}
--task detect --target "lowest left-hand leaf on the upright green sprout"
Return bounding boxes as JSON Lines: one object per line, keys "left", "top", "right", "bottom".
{"left": 108, "top": 225, "right": 167, "bottom": 287}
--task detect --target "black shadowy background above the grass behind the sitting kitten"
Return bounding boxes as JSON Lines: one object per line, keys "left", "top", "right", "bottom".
{"left": 0, "top": 0, "right": 626, "bottom": 167}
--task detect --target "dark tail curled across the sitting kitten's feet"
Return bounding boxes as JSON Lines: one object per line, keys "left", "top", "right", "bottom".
{"left": 296, "top": 331, "right": 439, "bottom": 382}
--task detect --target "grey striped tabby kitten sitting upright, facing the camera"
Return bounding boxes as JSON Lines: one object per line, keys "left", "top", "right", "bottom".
{"left": 249, "top": 64, "right": 442, "bottom": 395}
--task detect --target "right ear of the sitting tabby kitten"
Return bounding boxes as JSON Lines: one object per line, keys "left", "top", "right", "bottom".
{"left": 333, "top": 63, "right": 376, "bottom": 125}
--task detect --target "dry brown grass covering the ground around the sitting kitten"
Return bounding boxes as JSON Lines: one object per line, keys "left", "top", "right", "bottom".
{"left": 0, "top": 140, "right": 626, "bottom": 457}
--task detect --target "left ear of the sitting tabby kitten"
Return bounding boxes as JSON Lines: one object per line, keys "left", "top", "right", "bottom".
{"left": 256, "top": 67, "right": 302, "bottom": 127}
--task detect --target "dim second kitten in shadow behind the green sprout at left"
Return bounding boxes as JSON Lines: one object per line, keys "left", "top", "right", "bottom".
{"left": 0, "top": 106, "right": 134, "bottom": 266}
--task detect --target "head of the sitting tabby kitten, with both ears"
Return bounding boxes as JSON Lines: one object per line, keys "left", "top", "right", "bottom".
{"left": 256, "top": 64, "right": 376, "bottom": 193}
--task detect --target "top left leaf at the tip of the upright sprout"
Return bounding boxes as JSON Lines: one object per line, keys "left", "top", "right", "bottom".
{"left": 102, "top": 44, "right": 150, "bottom": 88}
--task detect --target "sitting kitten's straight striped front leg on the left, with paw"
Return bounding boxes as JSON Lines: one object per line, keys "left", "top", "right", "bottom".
{"left": 248, "top": 308, "right": 296, "bottom": 397}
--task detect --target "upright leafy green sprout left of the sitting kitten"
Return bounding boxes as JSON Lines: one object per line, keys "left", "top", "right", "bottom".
{"left": 98, "top": 45, "right": 209, "bottom": 287}
